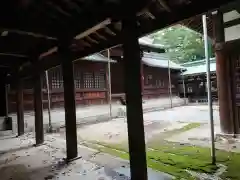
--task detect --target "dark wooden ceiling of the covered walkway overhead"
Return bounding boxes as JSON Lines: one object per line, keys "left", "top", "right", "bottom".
{"left": 0, "top": 0, "right": 237, "bottom": 82}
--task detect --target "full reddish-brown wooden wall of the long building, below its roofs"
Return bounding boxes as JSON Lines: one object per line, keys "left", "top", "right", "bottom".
{"left": 8, "top": 61, "right": 181, "bottom": 112}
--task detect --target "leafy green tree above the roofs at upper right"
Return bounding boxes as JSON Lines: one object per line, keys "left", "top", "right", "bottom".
{"left": 150, "top": 25, "right": 213, "bottom": 63}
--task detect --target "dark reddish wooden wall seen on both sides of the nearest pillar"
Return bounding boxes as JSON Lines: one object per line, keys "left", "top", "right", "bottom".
{"left": 111, "top": 62, "right": 179, "bottom": 99}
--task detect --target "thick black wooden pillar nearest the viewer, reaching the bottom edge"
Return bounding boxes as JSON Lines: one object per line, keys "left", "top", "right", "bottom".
{"left": 122, "top": 14, "right": 147, "bottom": 180}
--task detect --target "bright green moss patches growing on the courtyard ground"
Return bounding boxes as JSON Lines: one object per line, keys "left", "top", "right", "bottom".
{"left": 79, "top": 123, "right": 240, "bottom": 180}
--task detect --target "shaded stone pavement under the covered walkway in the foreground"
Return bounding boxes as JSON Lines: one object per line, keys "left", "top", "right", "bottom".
{"left": 0, "top": 133, "right": 173, "bottom": 180}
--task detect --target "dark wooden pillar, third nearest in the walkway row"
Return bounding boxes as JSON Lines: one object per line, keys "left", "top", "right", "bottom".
{"left": 33, "top": 72, "right": 44, "bottom": 145}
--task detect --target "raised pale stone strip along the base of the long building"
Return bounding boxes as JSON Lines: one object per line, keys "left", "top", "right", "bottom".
{"left": 9, "top": 97, "right": 184, "bottom": 132}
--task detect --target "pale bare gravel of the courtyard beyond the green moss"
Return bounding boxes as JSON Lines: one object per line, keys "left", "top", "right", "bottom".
{"left": 66, "top": 105, "right": 220, "bottom": 146}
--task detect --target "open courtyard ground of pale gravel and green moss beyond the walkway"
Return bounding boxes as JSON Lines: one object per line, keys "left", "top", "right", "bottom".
{"left": 61, "top": 105, "right": 240, "bottom": 180}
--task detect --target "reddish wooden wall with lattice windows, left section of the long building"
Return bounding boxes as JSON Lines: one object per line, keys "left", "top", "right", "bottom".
{"left": 8, "top": 61, "right": 107, "bottom": 112}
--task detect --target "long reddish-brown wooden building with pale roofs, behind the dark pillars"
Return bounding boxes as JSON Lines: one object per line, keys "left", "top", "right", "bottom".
{"left": 8, "top": 42, "right": 182, "bottom": 112}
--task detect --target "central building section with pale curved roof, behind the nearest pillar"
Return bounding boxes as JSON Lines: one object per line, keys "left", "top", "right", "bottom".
{"left": 106, "top": 44, "right": 183, "bottom": 99}
